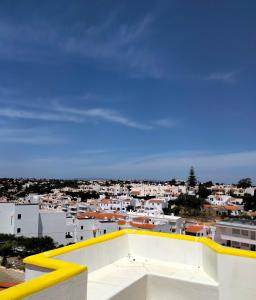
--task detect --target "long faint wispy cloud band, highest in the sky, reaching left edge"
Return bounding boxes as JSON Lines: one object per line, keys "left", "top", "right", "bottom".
{"left": 0, "top": 13, "right": 164, "bottom": 78}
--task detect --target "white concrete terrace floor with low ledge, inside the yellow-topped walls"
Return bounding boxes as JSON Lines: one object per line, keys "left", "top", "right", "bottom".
{"left": 87, "top": 257, "right": 218, "bottom": 300}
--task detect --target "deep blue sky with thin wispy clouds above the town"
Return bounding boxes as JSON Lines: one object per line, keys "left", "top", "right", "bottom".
{"left": 0, "top": 0, "right": 256, "bottom": 182}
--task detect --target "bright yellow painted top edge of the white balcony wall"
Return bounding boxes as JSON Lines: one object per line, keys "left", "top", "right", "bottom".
{"left": 0, "top": 229, "right": 256, "bottom": 300}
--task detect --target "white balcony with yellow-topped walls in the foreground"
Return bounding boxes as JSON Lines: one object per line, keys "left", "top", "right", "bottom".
{"left": 0, "top": 230, "right": 256, "bottom": 300}
